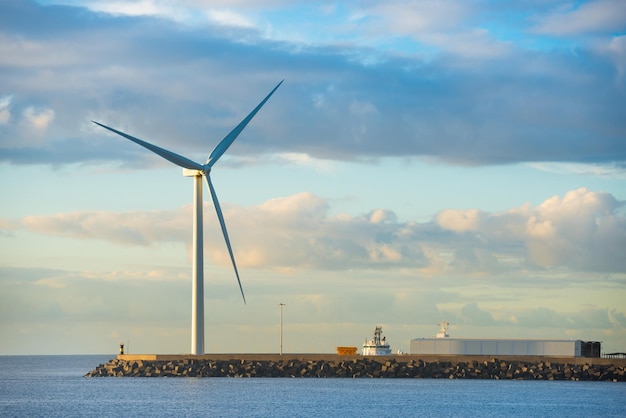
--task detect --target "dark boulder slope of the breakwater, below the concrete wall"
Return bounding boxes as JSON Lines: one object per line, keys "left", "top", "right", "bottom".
{"left": 85, "top": 357, "right": 626, "bottom": 382}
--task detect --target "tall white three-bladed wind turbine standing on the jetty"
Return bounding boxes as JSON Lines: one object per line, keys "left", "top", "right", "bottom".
{"left": 92, "top": 80, "right": 285, "bottom": 354}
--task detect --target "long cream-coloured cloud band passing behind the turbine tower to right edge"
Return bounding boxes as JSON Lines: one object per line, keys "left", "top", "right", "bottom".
{"left": 13, "top": 188, "right": 626, "bottom": 275}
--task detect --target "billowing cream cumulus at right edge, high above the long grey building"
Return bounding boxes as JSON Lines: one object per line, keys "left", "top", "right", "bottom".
{"left": 437, "top": 188, "right": 626, "bottom": 271}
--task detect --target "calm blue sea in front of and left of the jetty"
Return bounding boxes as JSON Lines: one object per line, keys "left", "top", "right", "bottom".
{"left": 0, "top": 355, "right": 626, "bottom": 417}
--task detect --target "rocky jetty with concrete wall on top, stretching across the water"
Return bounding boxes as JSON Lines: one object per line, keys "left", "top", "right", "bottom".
{"left": 85, "top": 354, "right": 626, "bottom": 382}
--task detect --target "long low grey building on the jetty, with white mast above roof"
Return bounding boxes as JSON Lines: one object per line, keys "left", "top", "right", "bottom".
{"left": 410, "top": 322, "right": 600, "bottom": 357}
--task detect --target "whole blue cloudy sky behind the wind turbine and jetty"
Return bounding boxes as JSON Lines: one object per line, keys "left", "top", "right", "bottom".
{"left": 0, "top": 0, "right": 626, "bottom": 354}
